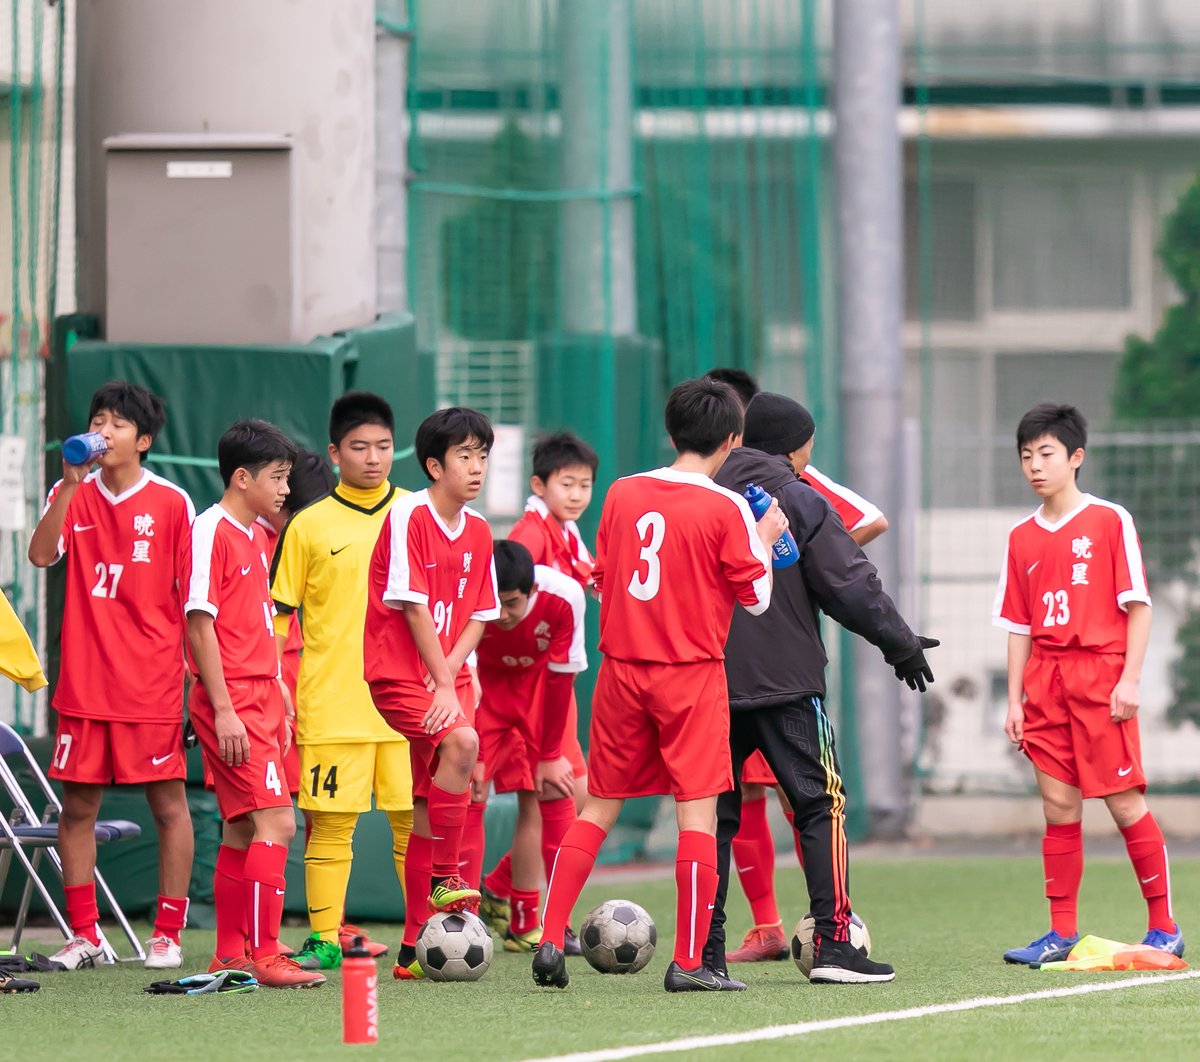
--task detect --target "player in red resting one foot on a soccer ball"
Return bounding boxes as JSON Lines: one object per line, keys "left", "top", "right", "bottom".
{"left": 362, "top": 407, "right": 500, "bottom": 980}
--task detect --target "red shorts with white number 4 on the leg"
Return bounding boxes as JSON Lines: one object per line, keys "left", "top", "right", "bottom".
{"left": 187, "top": 678, "right": 292, "bottom": 821}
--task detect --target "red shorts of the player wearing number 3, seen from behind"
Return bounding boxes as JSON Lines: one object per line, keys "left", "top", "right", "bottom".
{"left": 588, "top": 656, "right": 733, "bottom": 800}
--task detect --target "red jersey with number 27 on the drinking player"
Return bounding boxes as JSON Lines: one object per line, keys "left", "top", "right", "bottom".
{"left": 47, "top": 469, "right": 196, "bottom": 722}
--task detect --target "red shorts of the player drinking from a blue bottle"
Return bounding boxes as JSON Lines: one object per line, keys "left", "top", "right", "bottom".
{"left": 50, "top": 715, "right": 187, "bottom": 786}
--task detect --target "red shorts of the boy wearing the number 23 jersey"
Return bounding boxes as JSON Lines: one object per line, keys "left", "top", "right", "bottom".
{"left": 1021, "top": 649, "right": 1146, "bottom": 797}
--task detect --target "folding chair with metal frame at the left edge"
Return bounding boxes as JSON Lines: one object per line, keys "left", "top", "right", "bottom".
{"left": 0, "top": 722, "right": 145, "bottom": 962}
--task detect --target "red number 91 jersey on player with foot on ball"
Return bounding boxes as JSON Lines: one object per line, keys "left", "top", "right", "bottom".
{"left": 362, "top": 490, "right": 500, "bottom": 686}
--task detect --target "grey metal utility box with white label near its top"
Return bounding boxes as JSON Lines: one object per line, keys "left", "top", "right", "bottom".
{"left": 104, "top": 134, "right": 297, "bottom": 346}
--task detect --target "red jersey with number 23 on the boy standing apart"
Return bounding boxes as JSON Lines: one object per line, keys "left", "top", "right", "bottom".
{"left": 992, "top": 494, "right": 1150, "bottom": 653}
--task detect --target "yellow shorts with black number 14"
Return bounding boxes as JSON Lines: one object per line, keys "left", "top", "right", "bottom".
{"left": 296, "top": 742, "right": 413, "bottom": 812}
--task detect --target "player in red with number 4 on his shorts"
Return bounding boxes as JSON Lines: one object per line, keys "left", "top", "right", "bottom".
{"left": 184, "top": 420, "right": 325, "bottom": 988}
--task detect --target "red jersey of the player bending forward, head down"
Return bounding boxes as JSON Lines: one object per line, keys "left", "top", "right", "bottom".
{"left": 478, "top": 564, "right": 588, "bottom": 700}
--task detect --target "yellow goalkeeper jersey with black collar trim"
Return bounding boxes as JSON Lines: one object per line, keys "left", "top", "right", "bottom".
{"left": 271, "top": 484, "right": 408, "bottom": 745}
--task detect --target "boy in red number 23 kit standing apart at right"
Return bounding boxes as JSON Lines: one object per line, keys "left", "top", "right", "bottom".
{"left": 994, "top": 403, "right": 1183, "bottom": 964}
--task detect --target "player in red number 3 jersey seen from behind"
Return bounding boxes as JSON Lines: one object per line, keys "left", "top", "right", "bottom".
{"left": 533, "top": 379, "right": 787, "bottom": 991}
